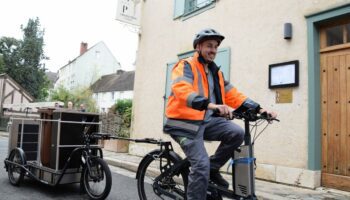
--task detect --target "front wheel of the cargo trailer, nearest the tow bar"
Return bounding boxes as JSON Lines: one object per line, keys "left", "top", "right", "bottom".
{"left": 83, "top": 158, "right": 112, "bottom": 200}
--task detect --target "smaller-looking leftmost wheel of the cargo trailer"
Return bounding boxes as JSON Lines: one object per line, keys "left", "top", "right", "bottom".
{"left": 7, "top": 148, "right": 26, "bottom": 186}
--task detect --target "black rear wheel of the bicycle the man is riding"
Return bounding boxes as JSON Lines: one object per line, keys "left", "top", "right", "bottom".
{"left": 137, "top": 154, "right": 189, "bottom": 200}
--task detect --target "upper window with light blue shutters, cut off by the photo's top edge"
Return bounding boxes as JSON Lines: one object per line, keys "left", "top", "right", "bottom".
{"left": 174, "top": 0, "right": 216, "bottom": 19}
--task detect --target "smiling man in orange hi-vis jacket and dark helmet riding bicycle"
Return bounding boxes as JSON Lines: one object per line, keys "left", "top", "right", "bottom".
{"left": 164, "top": 29, "right": 276, "bottom": 200}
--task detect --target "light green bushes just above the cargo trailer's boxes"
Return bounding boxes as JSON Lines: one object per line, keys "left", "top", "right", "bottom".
{"left": 50, "top": 86, "right": 97, "bottom": 112}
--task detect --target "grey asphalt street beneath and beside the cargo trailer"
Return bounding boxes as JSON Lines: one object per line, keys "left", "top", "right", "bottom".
{"left": 0, "top": 136, "right": 142, "bottom": 200}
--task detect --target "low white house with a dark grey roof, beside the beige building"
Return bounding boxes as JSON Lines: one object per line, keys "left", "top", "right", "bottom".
{"left": 91, "top": 70, "right": 135, "bottom": 112}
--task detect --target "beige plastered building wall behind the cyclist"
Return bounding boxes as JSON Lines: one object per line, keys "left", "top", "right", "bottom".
{"left": 130, "top": 0, "right": 350, "bottom": 186}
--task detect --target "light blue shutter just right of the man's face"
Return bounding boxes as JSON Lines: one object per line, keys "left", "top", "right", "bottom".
{"left": 214, "top": 48, "right": 231, "bottom": 81}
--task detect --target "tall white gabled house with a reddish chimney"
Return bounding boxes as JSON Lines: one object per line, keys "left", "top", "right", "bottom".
{"left": 55, "top": 41, "right": 121, "bottom": 89}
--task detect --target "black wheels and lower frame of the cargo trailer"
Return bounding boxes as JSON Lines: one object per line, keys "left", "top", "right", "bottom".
{"left": 4, "top": 120, "right": 112, "bottom": 200}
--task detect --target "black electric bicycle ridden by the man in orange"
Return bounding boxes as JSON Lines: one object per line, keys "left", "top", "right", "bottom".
{"left": 136, "top": 110, "right": 279, "bottom": 200}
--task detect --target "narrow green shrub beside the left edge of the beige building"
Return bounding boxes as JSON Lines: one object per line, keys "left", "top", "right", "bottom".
{"left": 115, "top": 99, "right": 132, "bottom": 137}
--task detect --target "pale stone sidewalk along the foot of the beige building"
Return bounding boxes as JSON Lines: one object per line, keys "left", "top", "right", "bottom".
{"left": 104, "top": 150, "right": 350, "bottom": 200}
